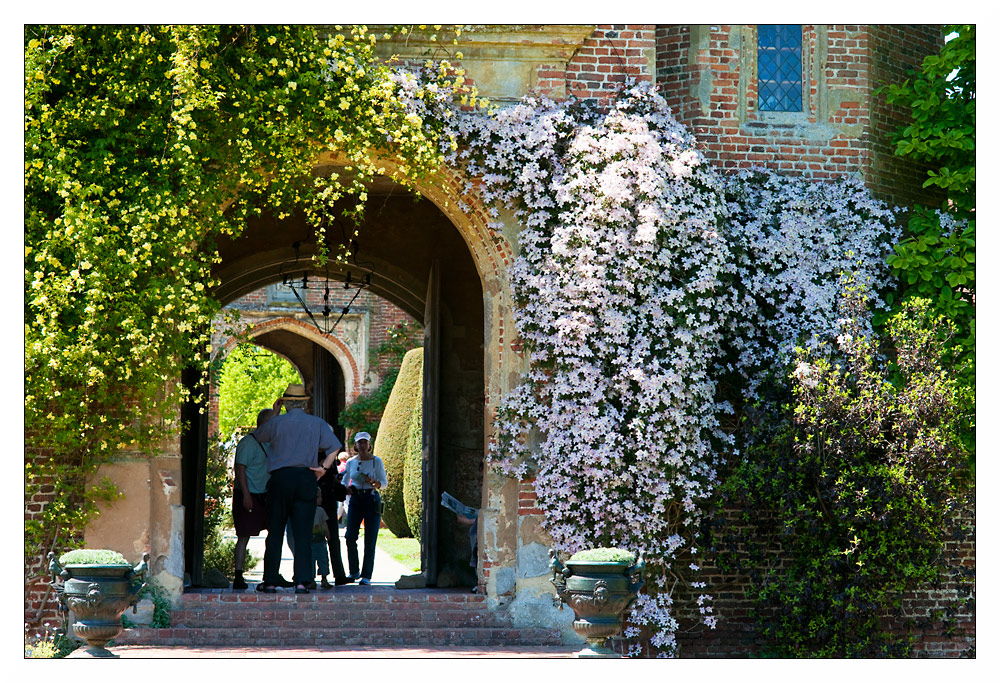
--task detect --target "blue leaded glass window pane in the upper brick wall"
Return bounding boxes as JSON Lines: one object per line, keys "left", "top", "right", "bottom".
{"left": 757, "top": 24, "right": 802, "bottom": 111}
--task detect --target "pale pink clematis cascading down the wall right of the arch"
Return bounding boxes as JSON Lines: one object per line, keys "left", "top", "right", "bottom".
{"left": 442, "top": 86, "right": 894, "bottom": 655}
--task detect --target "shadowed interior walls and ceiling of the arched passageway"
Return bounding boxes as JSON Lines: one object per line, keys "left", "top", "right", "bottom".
{"left": 182, "top": 168, "right": 495, "bottom": 585}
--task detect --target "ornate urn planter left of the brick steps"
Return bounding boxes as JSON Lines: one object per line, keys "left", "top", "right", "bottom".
{"left": 48, "top": 550, "right": 149, "bottom": 657}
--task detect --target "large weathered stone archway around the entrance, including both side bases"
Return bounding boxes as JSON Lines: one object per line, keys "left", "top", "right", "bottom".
{"left": 80, "top": 156, "right": 557, "bottom": 621}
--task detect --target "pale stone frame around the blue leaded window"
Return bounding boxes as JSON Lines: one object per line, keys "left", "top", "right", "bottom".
{"left": 737, "top": 24, "right": 829, "bottom": 127}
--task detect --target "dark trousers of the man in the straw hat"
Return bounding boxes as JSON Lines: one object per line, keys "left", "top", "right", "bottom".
{"left": 263, "top": 467, "right": 317, "bottom": 585}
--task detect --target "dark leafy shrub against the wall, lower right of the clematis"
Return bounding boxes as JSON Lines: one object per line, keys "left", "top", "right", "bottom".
{"left": 717, "top": 288, "right": 972, "bottom": 657}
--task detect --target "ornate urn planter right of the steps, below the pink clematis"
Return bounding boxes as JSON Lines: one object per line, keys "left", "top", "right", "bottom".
{"left": 549, "top": 548, "right": 644, "bottom": 657}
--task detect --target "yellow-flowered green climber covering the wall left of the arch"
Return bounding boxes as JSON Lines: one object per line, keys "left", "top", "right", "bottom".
{"left": 23, "top": 25, "right": 462, "bottom": 557}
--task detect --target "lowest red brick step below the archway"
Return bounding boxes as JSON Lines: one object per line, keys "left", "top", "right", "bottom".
{"left": 115, "top": 623, "right": 561, "bottom": 647}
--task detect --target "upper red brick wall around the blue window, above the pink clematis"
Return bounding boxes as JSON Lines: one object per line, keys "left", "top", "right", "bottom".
{"left": 560, "top": 24, "right": 943, "bottom": 205}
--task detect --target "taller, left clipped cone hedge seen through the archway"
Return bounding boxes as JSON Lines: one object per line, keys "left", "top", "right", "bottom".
{"left": 374, "top": 348, "right": 424, "bottom": 538}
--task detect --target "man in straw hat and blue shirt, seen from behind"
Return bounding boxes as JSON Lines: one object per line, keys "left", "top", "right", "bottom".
{"left": 254, "top": 384, "right": 343, "bottom": 593}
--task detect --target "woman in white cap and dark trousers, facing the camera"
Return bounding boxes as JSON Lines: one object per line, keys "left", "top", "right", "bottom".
{"left": 341, "top": 432, "right": 389, "bottom": 586}
